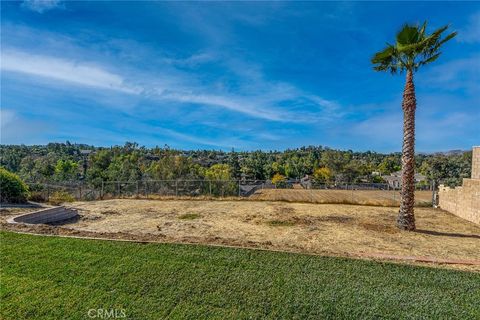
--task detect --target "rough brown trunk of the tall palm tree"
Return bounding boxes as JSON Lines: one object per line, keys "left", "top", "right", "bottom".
{"left": 397, "top": 70, "right": 417, "bottom": 230}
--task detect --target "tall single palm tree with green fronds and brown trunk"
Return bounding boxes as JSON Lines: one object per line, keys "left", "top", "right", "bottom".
{"left": 372, "top": 22, "right": 457, "bottom": 230}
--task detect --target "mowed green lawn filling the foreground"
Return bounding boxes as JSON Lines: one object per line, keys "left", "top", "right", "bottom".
{"left": 0, "top": 232, "right": 480, "bottom": 319}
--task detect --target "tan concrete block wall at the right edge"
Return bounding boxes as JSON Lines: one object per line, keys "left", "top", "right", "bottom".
{"left": 438, "top": 147, "right": 480, "bottom": 224}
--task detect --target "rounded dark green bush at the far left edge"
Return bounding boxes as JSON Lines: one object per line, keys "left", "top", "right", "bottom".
{"left": 0, "top": 168, "right": 29, "bottom": 203}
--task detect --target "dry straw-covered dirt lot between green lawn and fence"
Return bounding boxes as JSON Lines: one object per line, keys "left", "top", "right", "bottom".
{"left": 1, "top": 199, "right": 480, "bottom": 270}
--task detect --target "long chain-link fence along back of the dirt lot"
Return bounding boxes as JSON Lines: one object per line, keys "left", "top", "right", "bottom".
{"left": 30, "top": 180, "right": 434, "bottom": 205}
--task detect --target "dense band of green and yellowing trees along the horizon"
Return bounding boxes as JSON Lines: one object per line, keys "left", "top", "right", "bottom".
{"left": 0, "top": 141, "right": 471, "bottom": 187}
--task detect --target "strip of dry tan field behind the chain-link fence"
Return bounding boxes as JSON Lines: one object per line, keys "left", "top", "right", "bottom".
{"left": 250, "top": 189, "right": 432, "bottom": 206}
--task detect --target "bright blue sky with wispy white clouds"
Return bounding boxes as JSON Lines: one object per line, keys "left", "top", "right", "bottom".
{"left": 1, "top": 0, "right": 480, "bottom": 152}
